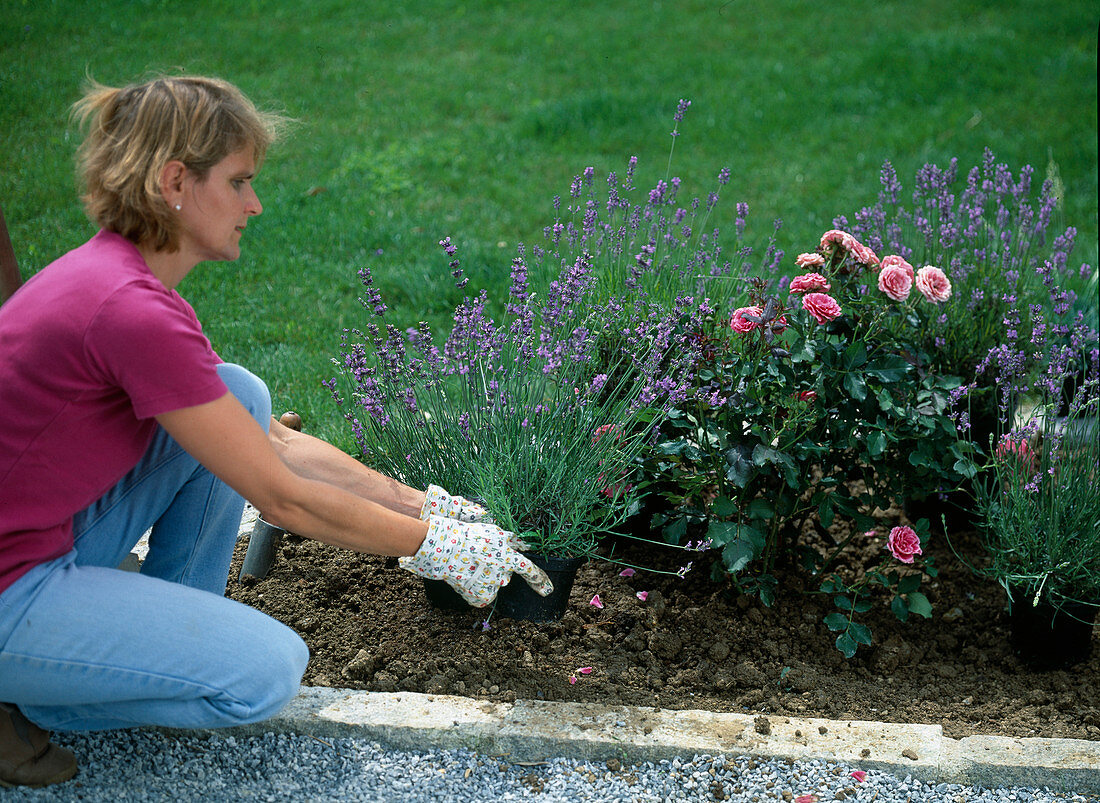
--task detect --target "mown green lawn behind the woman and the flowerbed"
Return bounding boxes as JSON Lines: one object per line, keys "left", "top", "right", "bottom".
{"left": 0, "top": 0, "right": 1098, "bottom": 448}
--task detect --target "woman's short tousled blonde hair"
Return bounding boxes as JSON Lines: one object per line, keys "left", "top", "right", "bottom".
{"left": 72, "top": 76, "right": 288, "bottom": 252}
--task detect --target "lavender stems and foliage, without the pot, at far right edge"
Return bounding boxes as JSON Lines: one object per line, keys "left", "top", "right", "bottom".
{"left": 959, "top": 262, "right": 1100, "bottom": 608}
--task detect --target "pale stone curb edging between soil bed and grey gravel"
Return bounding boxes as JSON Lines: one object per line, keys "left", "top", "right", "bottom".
{"left": 173, "top": 686, "right": 1100, "bottom": 793}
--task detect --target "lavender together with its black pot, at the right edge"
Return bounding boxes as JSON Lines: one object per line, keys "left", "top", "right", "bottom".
{"left": 976, "top": 361, "right": 1100, "bottom": 669}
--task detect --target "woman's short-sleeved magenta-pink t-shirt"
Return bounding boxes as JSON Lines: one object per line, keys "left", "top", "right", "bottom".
{"left": 0, "top": 231, "right": 228, "bottom": 591}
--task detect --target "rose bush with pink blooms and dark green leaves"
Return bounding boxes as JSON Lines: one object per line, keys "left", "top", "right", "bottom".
{"left": 642, "top": 230, "right": 960, "bottom": 655}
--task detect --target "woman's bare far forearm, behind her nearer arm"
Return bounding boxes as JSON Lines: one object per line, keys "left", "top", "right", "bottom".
{"left": 265, "top": 418, "right": 425, "bottom": 518}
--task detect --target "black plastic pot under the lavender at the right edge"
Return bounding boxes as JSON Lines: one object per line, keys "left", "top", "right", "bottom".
{"left": 1009, "top": 589, "right": 1097, "bottom": 669}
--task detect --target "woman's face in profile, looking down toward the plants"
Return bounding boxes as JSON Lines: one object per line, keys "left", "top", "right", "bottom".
{"left": 178, "top": 147, "right": 264, "bottom": 264}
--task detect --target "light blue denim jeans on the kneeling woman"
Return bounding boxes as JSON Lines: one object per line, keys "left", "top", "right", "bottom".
{"left": 0, "top": 364, "right": 309, "bottom": 730}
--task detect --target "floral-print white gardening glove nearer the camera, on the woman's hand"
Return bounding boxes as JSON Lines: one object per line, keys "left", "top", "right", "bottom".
{"left": 398, "top": 516, "right": 553, "bottom": 608}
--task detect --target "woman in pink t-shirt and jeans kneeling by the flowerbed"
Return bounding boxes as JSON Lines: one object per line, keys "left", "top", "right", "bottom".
{"left": 0, "top": 72, "right": 550, "bottom": 785}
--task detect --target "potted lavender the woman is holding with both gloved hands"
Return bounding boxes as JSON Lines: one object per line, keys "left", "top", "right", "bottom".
{"left": 327, "top": 239, "right": 678, "bottom": 619}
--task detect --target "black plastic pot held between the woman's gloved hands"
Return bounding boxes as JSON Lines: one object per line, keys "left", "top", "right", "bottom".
{"left": 424, "top": 553, "right": 586, "bottom": 622}
